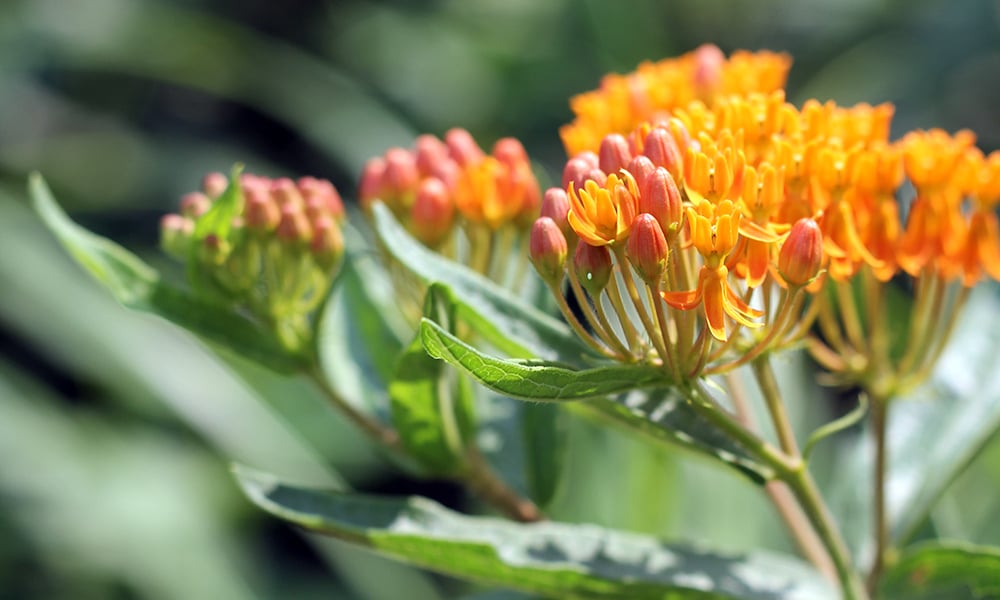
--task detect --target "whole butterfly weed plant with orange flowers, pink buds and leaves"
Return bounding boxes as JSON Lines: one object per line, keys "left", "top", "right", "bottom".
{"left": 30, "top": 46, "right": 1000, "bottom": 599}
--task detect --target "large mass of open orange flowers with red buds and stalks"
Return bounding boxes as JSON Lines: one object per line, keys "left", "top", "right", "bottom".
{"left": 530, "top": 47, "right": 1000, "bottom": 395}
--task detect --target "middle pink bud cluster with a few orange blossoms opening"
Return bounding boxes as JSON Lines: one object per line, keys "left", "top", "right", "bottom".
{"left": 359, "top": 129, "right": 541, "bottom": 290}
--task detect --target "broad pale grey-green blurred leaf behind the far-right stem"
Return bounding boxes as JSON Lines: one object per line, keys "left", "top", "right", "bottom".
{"left": 830, "top": 289, "right": 1000, "bottom": 557}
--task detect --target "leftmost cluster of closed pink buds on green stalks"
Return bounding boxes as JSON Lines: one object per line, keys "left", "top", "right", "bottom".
{"left": 161, "top": 173, "right": 344, "bottom": 351}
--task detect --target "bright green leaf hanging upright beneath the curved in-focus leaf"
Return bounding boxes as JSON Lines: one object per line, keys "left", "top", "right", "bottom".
{"left": 389, "top": 285, "right": 475, "bottom": 474}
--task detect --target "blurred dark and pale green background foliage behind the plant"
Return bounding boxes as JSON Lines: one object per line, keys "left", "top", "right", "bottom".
{"left": 0, "top": 0, "right": 1000, "bottom": 600}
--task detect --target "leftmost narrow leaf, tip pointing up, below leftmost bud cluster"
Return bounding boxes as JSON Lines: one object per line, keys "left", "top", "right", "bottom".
{"left": 28, "top": 174, "right": 304, "bottom": 372}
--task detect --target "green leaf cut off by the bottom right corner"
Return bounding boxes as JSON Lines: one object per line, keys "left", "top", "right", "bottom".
{"left": 879, "top": 543, "right": 1000, "bottom": 600}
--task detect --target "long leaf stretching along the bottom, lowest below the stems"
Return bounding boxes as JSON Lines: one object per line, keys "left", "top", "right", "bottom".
{"left": 236, "top": 469, "right": 835, "bottom": 600}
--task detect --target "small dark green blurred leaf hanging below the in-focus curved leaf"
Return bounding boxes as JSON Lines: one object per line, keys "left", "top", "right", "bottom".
{"left": 521, "top": 403, "right": 567, "bottom": 507}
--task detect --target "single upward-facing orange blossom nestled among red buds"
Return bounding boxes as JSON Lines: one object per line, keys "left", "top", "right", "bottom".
{"left": 567, "top": 171, "right": 639, "bottom": 246}
